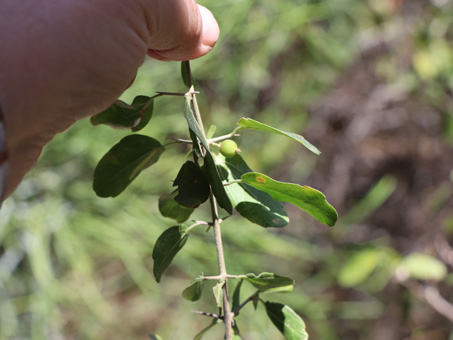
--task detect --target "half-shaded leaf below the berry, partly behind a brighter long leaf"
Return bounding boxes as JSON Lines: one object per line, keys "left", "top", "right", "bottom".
{"left": 216, "top": 155, "right": 289, "bottom": 228}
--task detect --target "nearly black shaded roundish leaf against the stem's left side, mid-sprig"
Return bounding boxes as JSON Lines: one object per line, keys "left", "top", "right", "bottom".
{"left": 173, "top": 161, "right": 211, "bottom": 208}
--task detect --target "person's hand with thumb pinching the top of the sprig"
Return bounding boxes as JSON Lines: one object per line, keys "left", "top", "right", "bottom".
{"left": 0, "top": 0, "right": 219, "bottom": 195}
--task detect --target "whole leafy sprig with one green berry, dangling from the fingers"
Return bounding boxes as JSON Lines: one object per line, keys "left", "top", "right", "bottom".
{"left": 91, "top": 62, "right": 337, "bottom": 340}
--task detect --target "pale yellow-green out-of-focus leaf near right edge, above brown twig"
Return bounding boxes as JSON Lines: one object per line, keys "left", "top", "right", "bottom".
{"left": 397, "top": 253, "right": 447, "bottom": 281}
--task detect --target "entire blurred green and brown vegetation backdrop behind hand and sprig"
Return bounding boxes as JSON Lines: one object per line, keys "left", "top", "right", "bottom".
{"left": 0, "top": 0, "right": 453, "bottom": 340}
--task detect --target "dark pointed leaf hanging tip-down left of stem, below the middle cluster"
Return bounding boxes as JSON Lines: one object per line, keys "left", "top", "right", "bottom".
{"left": 152, "top": 225, "right": 189, "bottom": 282}
